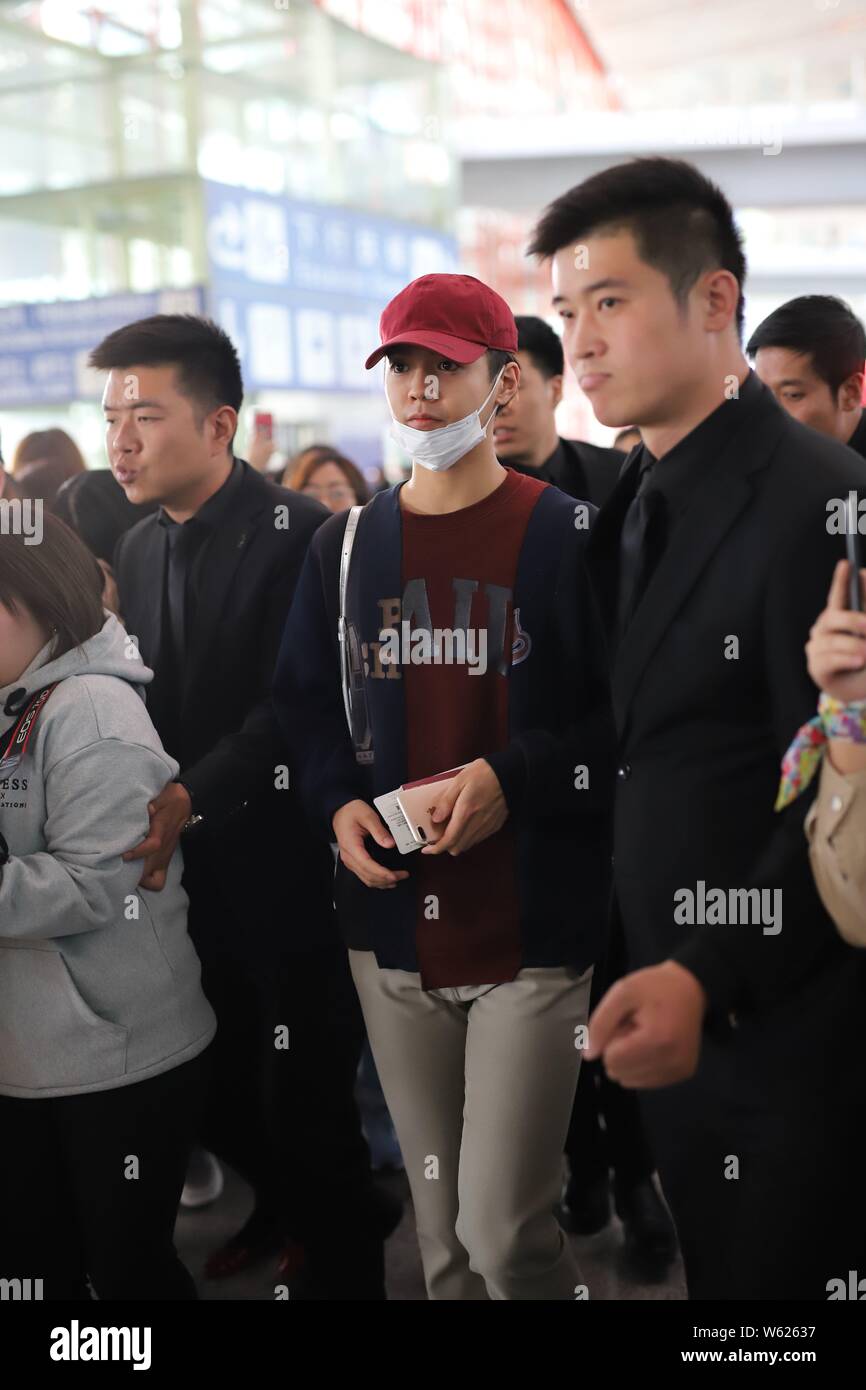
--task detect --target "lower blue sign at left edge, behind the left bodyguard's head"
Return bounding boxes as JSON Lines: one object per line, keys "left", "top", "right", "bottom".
{"left": 0, "top": 289, "right": 204, "bottom": 406}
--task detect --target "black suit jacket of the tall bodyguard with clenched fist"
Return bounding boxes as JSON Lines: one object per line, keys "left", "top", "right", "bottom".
{"left": 588, "top": 386, "right": 866, "bottom": 1019}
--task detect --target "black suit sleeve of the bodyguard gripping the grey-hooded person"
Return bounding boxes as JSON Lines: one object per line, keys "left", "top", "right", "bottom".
{"left": 178, "top": 499, "right": 328, "bottom": 820}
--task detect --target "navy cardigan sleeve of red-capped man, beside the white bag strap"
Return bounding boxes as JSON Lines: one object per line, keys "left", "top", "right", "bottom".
{"left": 274, "top": 513, "right": 367, "bottom": 840}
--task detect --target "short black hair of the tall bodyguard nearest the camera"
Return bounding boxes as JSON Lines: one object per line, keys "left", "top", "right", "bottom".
{"left": 528, "top": 156, "right": 746, "bottom": 336}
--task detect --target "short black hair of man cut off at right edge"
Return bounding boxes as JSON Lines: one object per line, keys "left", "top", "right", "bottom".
{"left": 745, "top": 295, "right": 866, "bottom": 396}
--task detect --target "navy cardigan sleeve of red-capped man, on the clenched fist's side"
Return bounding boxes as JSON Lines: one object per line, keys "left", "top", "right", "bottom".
{"left": 487, "top": 527, "right": 616, "bottom": 816}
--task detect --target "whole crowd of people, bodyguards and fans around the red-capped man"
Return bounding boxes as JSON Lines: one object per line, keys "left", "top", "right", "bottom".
{"left": 0, "top": 158, "right": 866, "bottom": 1301}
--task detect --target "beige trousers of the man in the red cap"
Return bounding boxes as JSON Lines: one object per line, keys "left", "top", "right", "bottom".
{"left": 349, "top": 951, "right": 592, "bottom": 1300}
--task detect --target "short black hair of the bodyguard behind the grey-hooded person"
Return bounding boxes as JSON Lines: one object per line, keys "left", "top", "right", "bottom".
{"left": 89, "top": 314, "right": 243, "bottom": 418}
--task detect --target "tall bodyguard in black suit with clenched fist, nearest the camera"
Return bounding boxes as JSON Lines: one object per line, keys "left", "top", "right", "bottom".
{"left": 532, "top": 160, "right": 866, "bottom": 1300}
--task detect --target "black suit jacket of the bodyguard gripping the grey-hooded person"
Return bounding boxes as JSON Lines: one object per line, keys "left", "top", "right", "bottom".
{"left": 114, "top": 463, "right": 334, "bottom": 945}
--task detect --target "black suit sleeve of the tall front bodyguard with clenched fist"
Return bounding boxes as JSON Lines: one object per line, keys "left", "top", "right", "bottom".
{"left": 674, "top": 502, "right": 840, "bottom": 1012}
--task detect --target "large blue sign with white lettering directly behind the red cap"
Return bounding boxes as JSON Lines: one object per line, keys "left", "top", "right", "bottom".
{"left": 204, "top": 181, "right": 457, "bottom": 391}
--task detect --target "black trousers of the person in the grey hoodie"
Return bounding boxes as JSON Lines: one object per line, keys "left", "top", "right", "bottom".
{"left": 0, "top": 1049, "right": 209, "bottom": 1301}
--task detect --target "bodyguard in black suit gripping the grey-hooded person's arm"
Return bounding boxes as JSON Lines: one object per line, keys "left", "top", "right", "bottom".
{"left": 92, "top": 316, "right": 384, "bottom": 1298}
